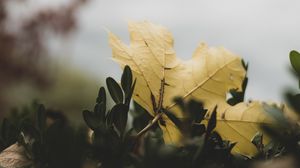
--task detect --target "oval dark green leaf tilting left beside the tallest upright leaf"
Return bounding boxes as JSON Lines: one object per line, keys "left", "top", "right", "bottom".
{"left": 106, "top": 77, "right": 124, "bottom": 104}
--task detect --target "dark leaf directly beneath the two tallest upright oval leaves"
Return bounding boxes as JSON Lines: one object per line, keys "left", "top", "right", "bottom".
{"left": 111, "top": 104, "right": 129, "bottom": 135}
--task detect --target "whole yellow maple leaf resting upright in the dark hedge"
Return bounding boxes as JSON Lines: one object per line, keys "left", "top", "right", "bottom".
{"left": 109, "top": 22, "right": 270, "bottom": 150}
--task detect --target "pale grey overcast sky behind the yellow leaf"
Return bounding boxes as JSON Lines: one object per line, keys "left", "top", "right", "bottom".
{"left": 14, "top": 0, "right": 300, "bottom": 100}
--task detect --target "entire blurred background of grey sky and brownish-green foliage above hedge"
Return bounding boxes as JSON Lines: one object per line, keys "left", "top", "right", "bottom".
{"left": 0, "top": 0, "right": 300, "bottom": 120}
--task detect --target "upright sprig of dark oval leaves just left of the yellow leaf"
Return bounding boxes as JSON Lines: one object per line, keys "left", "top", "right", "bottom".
{"left": 83, "top": 66, "right": 135, "bottom": 167}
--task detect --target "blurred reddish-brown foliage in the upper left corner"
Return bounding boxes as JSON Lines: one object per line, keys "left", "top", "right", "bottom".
{"left": 0, "top": 0, "right": 86, "bottom": 115}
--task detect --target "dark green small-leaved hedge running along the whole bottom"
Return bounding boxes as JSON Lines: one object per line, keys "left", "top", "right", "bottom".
{"left": 0, "top": 53, "right": 300, "bottom": 168}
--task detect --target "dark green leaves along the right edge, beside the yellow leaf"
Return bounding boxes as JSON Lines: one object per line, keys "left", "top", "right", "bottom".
{"left": 256, "top": 51, "right": 300, "bottom": 160}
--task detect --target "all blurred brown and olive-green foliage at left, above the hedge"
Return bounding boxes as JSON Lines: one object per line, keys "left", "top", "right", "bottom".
{"left": 0, "top": 0, "right": 99, "bottom": 121}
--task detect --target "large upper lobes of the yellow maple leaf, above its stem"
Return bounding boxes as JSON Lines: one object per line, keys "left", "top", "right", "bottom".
{"left": 109, "top": 22, "right": 245, "bottom": 113}
